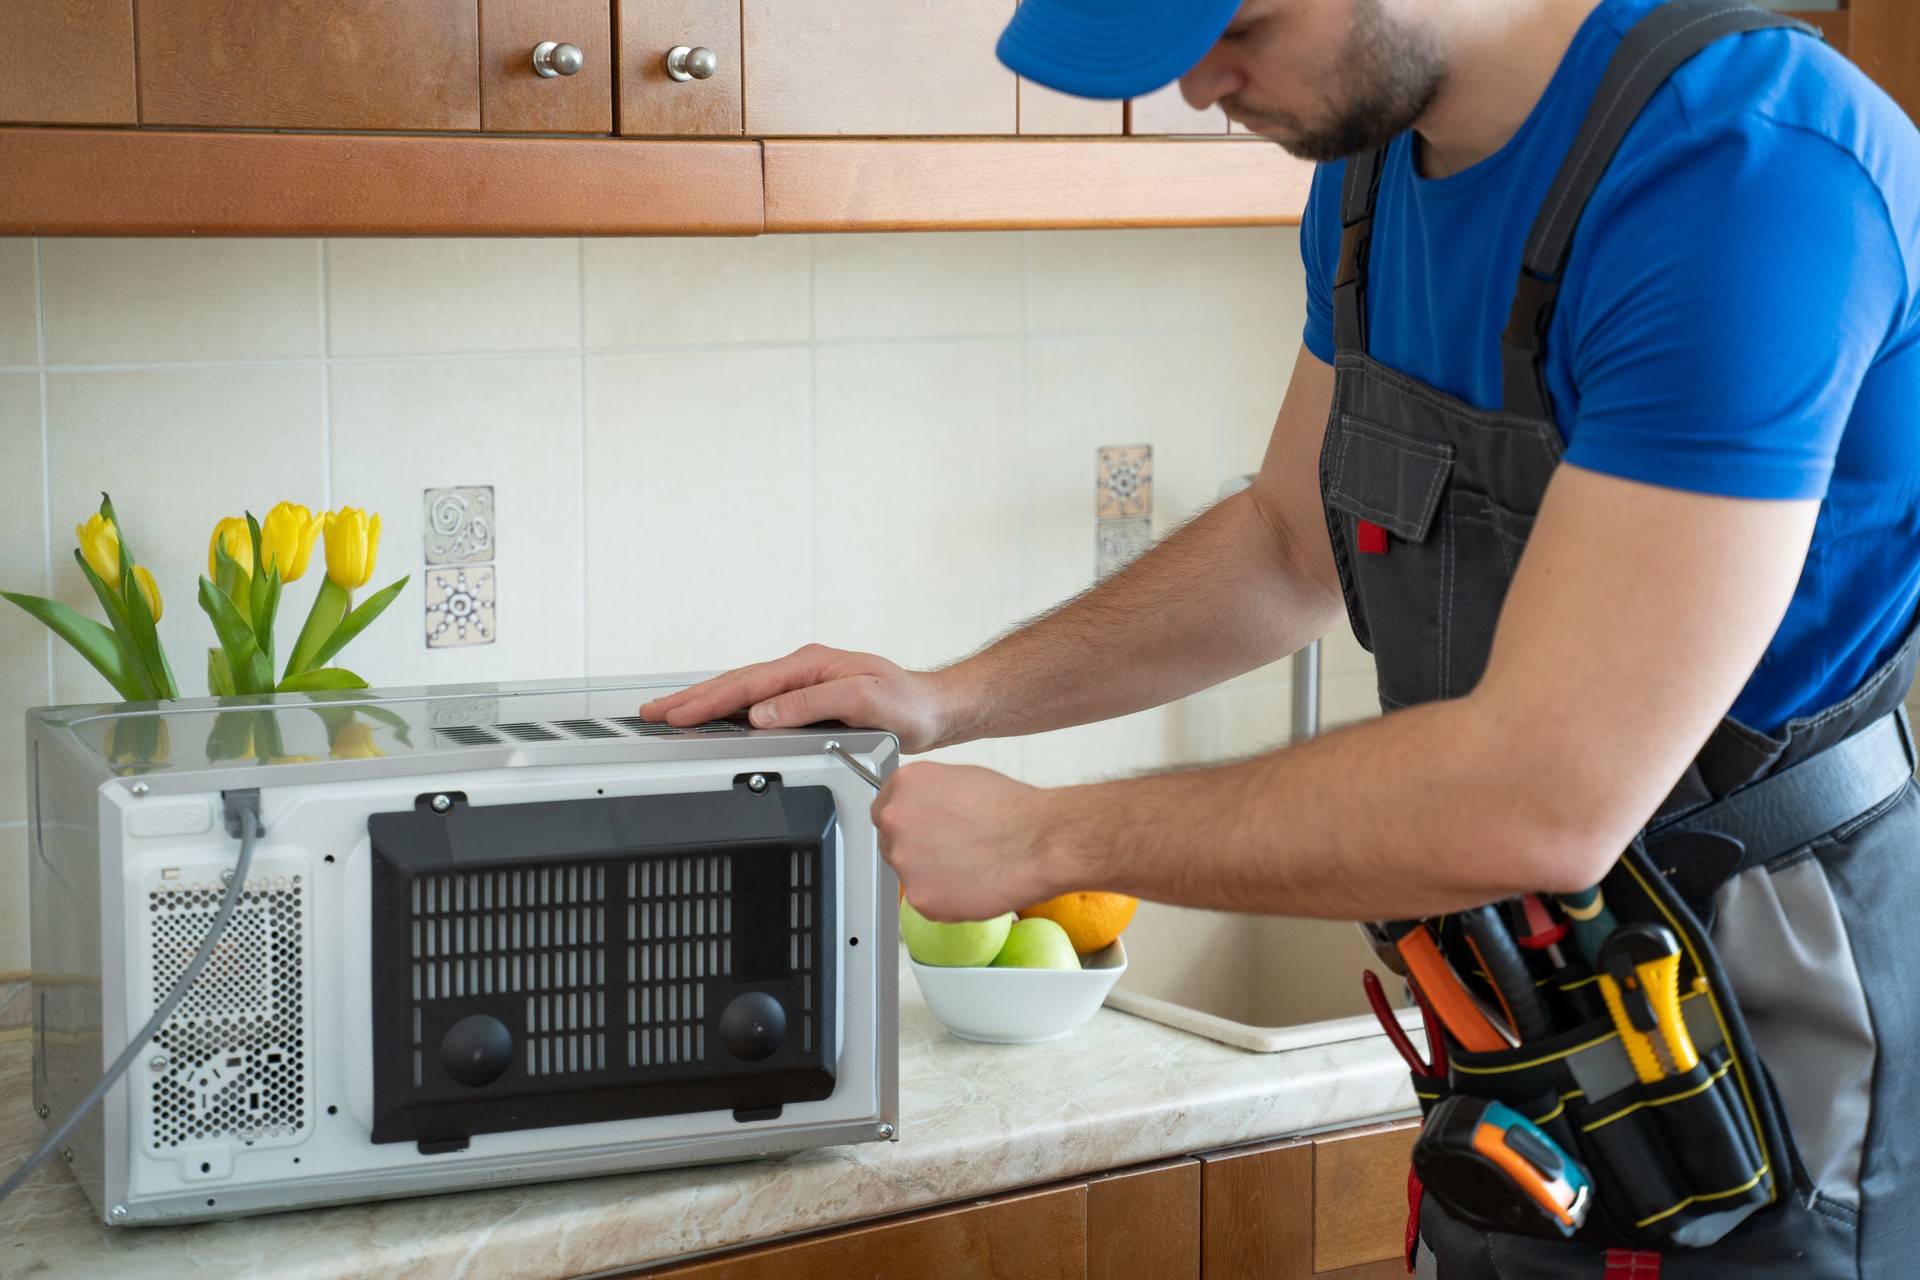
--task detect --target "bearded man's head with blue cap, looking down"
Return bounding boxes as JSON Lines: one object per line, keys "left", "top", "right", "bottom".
{"left": 1000, "top": 0, "right": 1446, "bottom": 161}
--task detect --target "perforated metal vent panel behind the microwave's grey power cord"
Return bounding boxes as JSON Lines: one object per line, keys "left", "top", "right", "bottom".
{"left": 148, "top": 875, "right": 311, "bottom": 1151}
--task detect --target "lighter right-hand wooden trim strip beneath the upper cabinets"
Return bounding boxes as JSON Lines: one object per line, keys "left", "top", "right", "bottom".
{"left": 762, "top": 138, "right": 1313, "bottom": 232}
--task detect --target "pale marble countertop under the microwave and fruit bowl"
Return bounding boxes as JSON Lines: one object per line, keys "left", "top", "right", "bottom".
{"left": 0, "top": 965, "right": 1413, "bottom": 1280}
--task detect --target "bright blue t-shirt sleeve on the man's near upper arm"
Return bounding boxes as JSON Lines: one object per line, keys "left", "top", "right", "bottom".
{"left": 1559, "top": 115, "right": 1910, "bottom": 499}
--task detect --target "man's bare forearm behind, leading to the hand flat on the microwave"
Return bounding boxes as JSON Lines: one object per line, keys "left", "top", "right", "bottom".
{"left": 941, "top": 489, "right": 1344, "bottom": 747}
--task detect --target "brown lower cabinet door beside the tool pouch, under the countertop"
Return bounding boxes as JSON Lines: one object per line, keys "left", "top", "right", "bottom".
{"left": 1200, "top": 1121, "right": 1419, "bottom": 1280}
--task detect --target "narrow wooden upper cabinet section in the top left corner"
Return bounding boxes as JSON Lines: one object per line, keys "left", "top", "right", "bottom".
{"left": 0, "top": 0, "right": 136, "bottom": 125}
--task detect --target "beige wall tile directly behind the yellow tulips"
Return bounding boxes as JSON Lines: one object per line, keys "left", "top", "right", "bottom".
{"left": 48, "top": 365, "right": 326, "bottom": 702}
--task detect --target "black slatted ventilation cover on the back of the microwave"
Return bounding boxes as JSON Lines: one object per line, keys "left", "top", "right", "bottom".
{"left": 369, "top": 779, "right": 835, "bottom": 1144}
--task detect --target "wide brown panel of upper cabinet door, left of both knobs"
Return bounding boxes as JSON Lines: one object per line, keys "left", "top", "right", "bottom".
{"left": 136, "top": 0, "right": 480, "bottom": 130}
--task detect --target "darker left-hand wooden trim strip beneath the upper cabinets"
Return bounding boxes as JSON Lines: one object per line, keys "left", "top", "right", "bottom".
{"left": 0, "top": 129, "right": 764, "bottom": 236}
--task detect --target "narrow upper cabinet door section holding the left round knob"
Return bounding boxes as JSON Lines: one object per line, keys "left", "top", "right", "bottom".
{"left": 480, "top": 0, "right": 612, "bottom": 132}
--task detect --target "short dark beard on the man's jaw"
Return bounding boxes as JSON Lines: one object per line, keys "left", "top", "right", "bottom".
{"left": 1221, "top": 0, "right": 1446, "bottom": 163}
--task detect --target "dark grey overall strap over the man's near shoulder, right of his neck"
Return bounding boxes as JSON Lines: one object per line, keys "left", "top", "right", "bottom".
{"left": 1500, "top": 0, "right": 1818, "bottom": 418}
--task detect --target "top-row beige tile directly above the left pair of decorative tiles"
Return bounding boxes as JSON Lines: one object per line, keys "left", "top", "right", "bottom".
{"left": 326, "top": 240, "right": 580, "bottom": 355}
